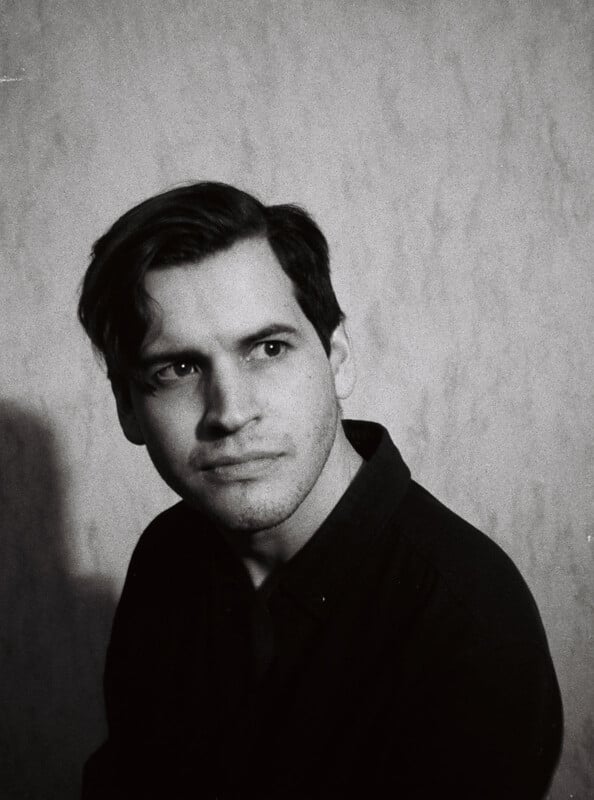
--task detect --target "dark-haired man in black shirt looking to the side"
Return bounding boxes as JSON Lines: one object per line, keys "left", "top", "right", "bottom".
{"left": 79, "top": 183, "right": 561, "bottom": 800}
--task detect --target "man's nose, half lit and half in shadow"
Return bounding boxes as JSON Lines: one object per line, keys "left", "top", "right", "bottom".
{"left": 201, "top": 364, "right": 259, "bottom": 436}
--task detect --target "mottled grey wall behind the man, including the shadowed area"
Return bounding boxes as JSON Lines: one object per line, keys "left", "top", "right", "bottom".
{"left": 0, "top": 0, "right": 594, "bottom": 800}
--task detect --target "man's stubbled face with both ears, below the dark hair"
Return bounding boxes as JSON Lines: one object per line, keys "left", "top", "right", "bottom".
{"left": 118, "top": 239, "right": 351, "bottom": 531}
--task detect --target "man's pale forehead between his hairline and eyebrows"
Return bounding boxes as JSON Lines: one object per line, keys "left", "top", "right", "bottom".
{"left": 144, "top": 238, "right": 302, "bottom": 347}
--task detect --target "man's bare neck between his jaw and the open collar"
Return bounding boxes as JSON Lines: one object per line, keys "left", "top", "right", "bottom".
{"left": 221, "top": 423, "right": 362, "bottom": 587}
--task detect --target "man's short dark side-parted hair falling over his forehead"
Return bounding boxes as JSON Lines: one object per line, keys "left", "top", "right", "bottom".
{"left": 78, "top": 181, "right": 344, "bottom": 384}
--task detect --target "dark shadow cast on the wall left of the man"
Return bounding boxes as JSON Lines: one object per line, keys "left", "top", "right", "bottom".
{"left": 0, "top": 402, "right": 115, "bottom": 800}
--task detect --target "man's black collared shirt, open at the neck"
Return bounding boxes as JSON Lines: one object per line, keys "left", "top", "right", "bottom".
{"left": 83, "top": 422, "right": 562, "bottom": 800}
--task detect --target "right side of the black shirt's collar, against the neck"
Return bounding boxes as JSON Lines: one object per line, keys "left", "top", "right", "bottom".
{"left": 272, "top": 420, "right": 410, "bottom": 620}
